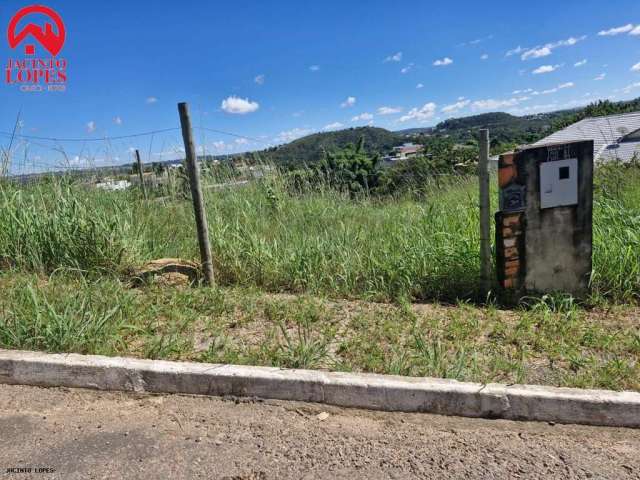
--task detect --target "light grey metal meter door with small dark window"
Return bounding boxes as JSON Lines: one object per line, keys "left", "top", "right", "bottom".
{"left": 540, "top": 158, "right": 578, "bottom": 208}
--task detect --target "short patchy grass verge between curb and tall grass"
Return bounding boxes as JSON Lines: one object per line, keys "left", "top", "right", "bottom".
{"left": 0, "top": 273, "right": 640, "bottom": 390}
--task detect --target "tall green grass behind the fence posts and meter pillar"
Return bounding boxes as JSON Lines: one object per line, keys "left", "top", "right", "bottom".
{"left": 0, "top": 162, "right": 640, "bottom": 301}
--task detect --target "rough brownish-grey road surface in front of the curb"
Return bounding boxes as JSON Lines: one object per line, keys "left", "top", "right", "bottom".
{"left": 0, "top": 385, "right": 640, "bottom": 480}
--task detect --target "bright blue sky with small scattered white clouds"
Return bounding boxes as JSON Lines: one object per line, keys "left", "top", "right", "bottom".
{"left": 0, "top": 0, "right": 640, "bottom": 173}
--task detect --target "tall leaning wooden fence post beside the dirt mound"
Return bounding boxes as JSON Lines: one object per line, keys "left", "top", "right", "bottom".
{"left": 178, "top": 102, "right": 214, "bottom": 286}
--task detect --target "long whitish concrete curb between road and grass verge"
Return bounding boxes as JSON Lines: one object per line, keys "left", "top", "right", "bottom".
{"left": 0, "top": 350, "right": 640, "bottom": 428}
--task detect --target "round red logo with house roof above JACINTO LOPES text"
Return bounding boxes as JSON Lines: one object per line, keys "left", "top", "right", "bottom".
{"left": 7, "top": 5, "right": 66, "bottom": 57}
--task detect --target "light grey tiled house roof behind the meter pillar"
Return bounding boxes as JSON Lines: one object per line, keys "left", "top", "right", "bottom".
{"left": 533, "top": 112, "right": 640, "bottom": 163}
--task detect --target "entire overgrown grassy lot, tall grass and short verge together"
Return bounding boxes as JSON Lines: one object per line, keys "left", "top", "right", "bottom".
{"left": 0, "top": 161, "right": 640, "bottom": 390}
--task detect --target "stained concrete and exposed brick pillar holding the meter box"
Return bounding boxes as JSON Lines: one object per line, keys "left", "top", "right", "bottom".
{"left": 496, "top": 141, "right": 593, "bottom": 297}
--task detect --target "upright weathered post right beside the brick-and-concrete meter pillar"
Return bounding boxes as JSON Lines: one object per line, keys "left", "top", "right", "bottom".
{"left": 478, "top": 129, "right": 491, "bottom": 297}
